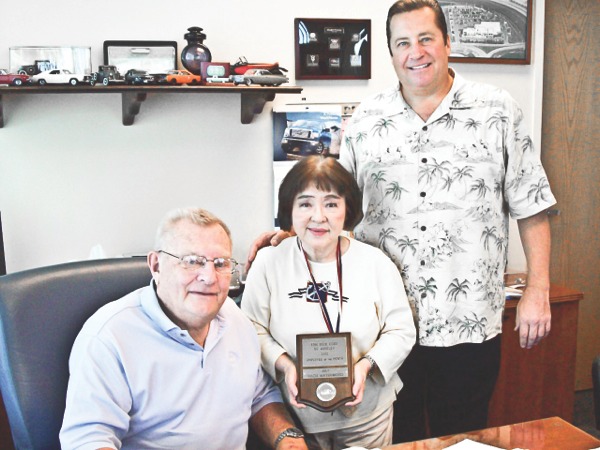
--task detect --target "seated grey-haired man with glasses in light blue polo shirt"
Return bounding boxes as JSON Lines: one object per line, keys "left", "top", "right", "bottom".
{"left": 60, "top": 209, "right": 307, "bottom": 450}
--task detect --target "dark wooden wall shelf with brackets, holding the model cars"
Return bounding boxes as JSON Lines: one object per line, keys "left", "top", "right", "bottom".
{"left": 0, "top": 85, "right": 302, "bottom": 128}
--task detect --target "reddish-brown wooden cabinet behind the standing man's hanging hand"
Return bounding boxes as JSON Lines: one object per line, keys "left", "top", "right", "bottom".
{"left": 488, "top": 282, "right": 583, "bottom": 426}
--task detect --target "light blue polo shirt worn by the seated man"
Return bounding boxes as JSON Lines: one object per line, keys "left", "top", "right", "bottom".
{"left": 60, "top": 286, "right": 281, "bottom": 449}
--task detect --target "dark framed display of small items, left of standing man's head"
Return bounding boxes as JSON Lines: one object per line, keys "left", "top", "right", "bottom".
{"left": 294, "top": 19, "right": 371, "bottom": 80}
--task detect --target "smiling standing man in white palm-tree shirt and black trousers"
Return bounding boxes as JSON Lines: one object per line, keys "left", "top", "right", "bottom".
{"left": 340, "top": 0, "right": 555, "bottom": 442}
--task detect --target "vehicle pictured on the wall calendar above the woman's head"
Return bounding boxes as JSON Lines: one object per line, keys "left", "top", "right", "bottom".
{"left": 281, "top": 119, "right": 340, "bottom": 154}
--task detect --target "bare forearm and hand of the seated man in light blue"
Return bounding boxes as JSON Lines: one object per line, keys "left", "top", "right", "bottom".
{"left": 250, "top": 402, "right": 308, "bottom": 450}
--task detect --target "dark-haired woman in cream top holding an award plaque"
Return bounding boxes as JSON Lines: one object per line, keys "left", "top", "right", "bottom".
{"left": 241, "top": 156, "right": 416, "bottom": 449}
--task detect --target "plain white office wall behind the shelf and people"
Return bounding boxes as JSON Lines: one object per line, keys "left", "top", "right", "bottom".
{"left": 0, "top": 0, "right": 544, "bottom": 272}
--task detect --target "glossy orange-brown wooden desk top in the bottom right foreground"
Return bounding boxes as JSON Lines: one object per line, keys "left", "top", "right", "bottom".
{"left": 383, "top": 417, "right": 600, "bottom": 450}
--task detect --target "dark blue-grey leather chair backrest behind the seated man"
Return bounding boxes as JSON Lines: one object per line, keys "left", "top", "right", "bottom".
{"left": 0, "top": 257, "right": 151, "bottom": 450}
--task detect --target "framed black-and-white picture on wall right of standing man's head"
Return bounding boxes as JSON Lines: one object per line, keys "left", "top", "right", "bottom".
{"left": 440, "top": 0, "right": 533, "bottom": 64}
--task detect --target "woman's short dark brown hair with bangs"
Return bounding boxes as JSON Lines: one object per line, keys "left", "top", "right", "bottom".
{"left": 277, "top": 155, "right": 363, "bottom": 231}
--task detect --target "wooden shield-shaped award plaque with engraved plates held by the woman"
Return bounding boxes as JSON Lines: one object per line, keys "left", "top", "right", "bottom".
{"left": 296, "top": 333, "right": 354, "bottom": 411}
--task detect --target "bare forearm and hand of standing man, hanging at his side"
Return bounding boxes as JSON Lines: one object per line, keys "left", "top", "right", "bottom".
{"left": 515, "top": 210, "right": 550, "bottom": 349}
